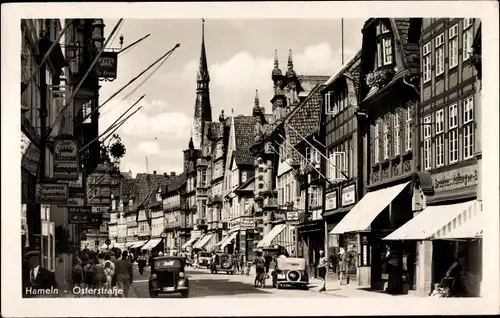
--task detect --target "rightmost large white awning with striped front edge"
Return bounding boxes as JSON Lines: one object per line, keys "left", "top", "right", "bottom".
{"left": 384, "top": 200, "right": 478, "bottom": 240}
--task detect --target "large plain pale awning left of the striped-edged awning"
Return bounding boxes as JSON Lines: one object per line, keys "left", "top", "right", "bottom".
{"left": 330, "top": 182, "right": 410, "bottom": 234}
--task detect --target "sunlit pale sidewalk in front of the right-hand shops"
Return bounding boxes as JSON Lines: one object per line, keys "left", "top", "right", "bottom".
{"left": 309, "top": 276, "right": 418, "bottom": 298}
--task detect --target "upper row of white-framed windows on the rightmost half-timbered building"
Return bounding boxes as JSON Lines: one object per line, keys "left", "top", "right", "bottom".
{"left": 422, "top": 18, "right": 474, "bottom": 83}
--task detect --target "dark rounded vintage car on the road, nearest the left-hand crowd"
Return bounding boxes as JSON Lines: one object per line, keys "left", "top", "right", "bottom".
{"left": 149, "top": 256, "right": 189, "bottom": 298}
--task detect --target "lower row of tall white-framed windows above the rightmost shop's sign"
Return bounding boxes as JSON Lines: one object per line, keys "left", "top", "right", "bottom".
{"left": 423, "top": 96, "right": 475, "bottom": 170}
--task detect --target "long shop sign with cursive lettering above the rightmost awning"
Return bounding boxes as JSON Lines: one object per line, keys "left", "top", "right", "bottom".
{"left": 432, "top": 165, "right": 479, "bottom": 192}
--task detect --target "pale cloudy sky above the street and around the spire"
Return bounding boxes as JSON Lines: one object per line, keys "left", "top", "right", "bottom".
{"left": 99, "top": 18, "right": 365, "bottom": 175}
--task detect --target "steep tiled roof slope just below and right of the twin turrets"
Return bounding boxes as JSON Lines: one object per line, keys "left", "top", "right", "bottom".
{"left": 284, "top": 85, "right": 324, "bottom": 146}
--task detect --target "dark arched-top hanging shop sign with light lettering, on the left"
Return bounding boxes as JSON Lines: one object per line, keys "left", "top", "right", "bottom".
{"left": 53, "top": 135, "right": 80, "bottom": 180}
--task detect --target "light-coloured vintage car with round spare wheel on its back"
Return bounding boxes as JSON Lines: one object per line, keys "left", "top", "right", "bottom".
{"left": 271, "top": 257, "right": 309, "bottom": 290}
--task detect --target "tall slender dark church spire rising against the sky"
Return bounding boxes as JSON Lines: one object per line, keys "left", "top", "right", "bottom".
{"left": 191, "top": 19, "right": 212, "bottom": 149}
